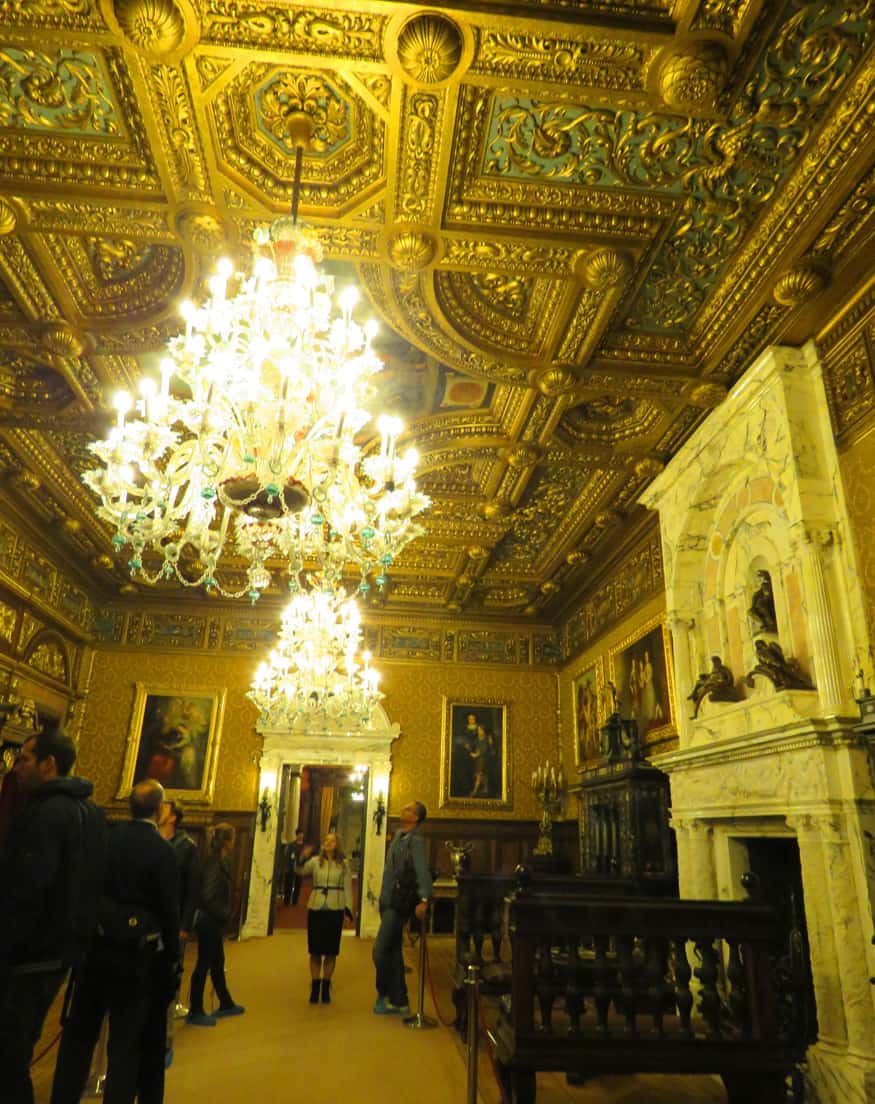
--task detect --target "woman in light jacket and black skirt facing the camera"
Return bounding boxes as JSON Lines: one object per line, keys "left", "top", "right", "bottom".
{"left": 301, "top": 831, "right": 353, "bottom": 1005}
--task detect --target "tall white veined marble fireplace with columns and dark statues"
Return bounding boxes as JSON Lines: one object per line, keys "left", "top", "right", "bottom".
{"left": 641, "top": 343, "right": 875, "bottom": 1104}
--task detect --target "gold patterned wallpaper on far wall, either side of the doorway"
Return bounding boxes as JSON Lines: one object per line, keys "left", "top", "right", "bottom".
{"left": 78, "top": 649, "right": 556, "bottom": 819}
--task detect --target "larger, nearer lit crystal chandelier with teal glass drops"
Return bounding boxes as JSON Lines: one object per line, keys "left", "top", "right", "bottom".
{"left": 83, "top": 216, "right": 429, "bottom": 602}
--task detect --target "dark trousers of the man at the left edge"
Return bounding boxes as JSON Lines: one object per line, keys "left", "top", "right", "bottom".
{"left": 0, "top": 969, "right": 67, "bottom": 1104}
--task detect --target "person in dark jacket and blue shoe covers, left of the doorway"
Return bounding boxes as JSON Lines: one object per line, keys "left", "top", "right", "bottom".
{"left": 188, "top": 824, "right": 246, "bottom": 1028}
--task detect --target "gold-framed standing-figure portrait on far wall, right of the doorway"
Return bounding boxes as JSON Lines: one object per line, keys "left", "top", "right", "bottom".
{"left": 440, "top": 698, "right": 512, "bottom": 809}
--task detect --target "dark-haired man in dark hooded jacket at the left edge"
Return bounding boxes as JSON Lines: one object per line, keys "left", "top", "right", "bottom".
{"left": 0, "top": 728, "right": 106, "bottom": 1104}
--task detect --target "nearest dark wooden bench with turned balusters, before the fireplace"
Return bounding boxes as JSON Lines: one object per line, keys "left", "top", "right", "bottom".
{"left": 490, "top": 893, "right": 804, "bottom": 1104}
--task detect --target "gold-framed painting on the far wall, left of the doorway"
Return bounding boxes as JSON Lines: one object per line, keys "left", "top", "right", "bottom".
{"left": 116, "top": 682, "right": 225, "bottom": 805}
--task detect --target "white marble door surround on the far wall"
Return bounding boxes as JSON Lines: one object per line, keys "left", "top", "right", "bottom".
{"left": 241, "top": 708, "right": 401, "bottom": 938}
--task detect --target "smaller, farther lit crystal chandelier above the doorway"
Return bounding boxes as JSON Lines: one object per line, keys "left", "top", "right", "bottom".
{"left": 247, "top": 591, "right": 383, "bottom": 729}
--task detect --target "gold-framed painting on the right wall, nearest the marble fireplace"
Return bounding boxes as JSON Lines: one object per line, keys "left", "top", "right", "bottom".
{"left": 609, "top": 618, "right": 676, "bottom": 744}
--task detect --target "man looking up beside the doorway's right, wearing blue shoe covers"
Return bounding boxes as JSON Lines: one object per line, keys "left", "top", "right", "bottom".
{"left": 374, "top": 802, "right": 431, "bottom": 1016}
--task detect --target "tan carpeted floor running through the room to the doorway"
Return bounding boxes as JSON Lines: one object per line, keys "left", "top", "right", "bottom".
{"left": 34, "top": 931, "right": 726, "bottom": 1104}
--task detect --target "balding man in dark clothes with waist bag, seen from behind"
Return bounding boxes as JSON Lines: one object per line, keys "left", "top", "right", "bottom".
{"left": 52, "top": 778, "right": 180, "bottom": 1104}
